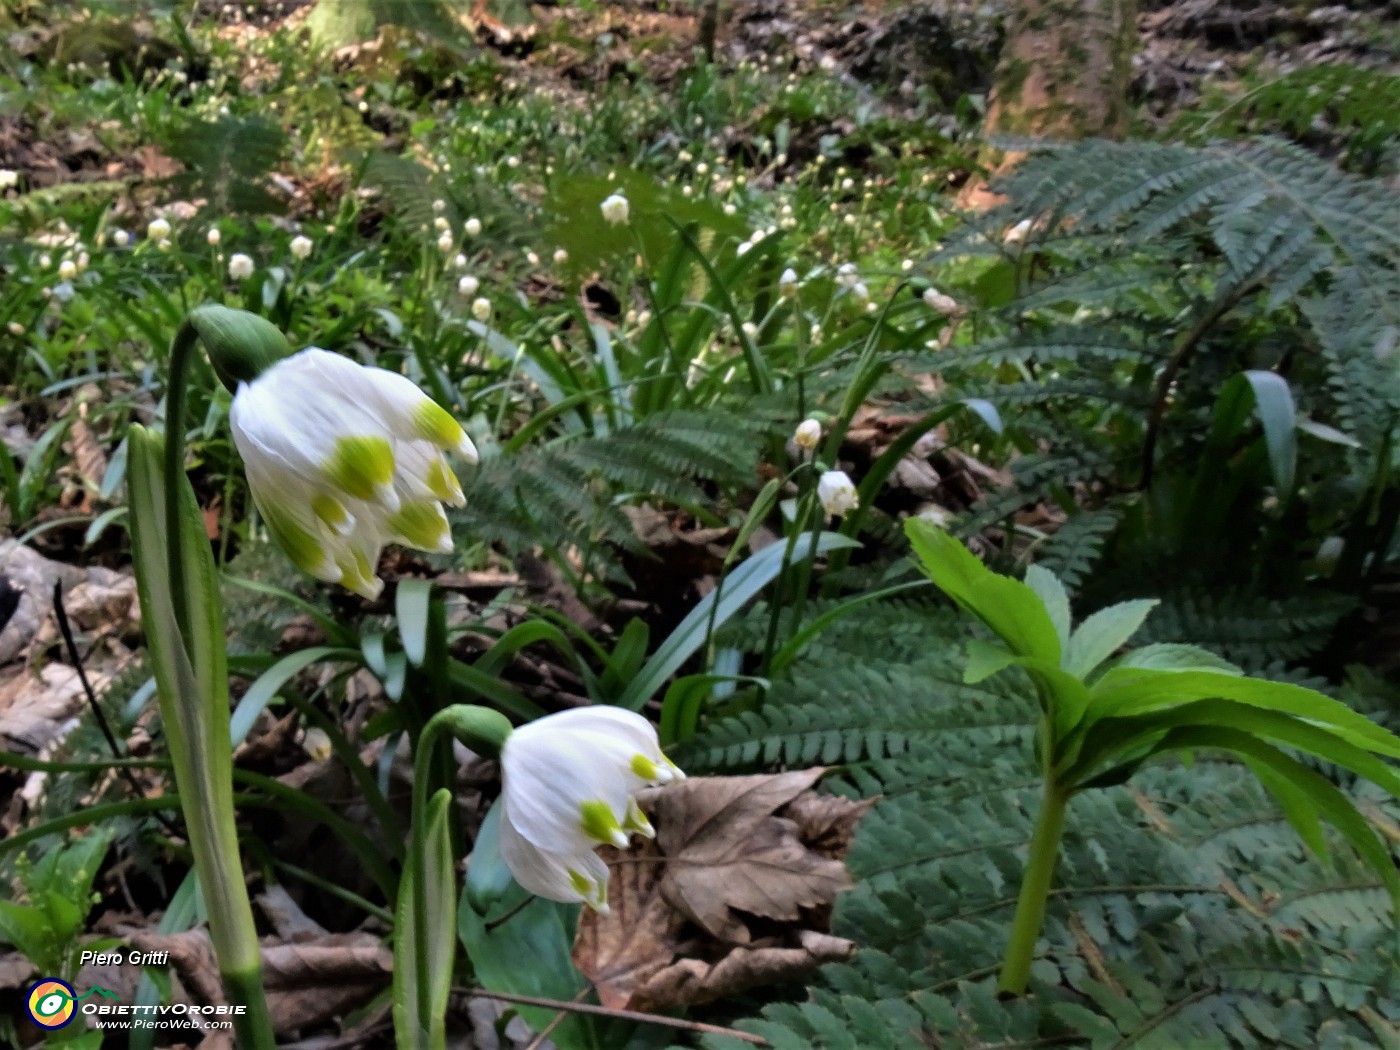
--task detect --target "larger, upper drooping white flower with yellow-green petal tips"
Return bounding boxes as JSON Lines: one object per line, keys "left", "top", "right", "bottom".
{"left": 228, "top": 347, "right": 476, "bottom": 599}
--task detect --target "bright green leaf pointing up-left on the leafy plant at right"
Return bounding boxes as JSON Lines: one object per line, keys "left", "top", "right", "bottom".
{"left": 904, "top": 518, "right": 1061, "bottom": 666}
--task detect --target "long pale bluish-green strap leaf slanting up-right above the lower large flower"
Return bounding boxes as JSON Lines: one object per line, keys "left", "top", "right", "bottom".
{"left": 617, "top": 532, "right": 860, "bottom": 711}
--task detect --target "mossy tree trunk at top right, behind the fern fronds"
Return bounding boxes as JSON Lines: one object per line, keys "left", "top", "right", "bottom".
{"left": 960, "top": 0, "right": 1138, "bottom": 207}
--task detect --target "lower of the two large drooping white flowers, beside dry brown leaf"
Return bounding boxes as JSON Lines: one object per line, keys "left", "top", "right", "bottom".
{"left": 500, "top": 706, "right": 685, "bottom": 911}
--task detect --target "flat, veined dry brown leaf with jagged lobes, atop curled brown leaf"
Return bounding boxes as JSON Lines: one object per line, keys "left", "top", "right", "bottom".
{"left": 648, "top": 767, "right": 851, "bottom": 945}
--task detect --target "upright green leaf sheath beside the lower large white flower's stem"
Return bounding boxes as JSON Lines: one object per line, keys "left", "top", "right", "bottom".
{"left": 393, "top": 788, "right": 456, "bottom": 1049}
